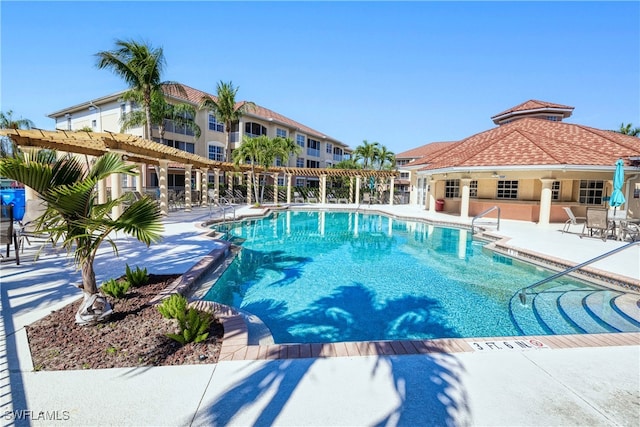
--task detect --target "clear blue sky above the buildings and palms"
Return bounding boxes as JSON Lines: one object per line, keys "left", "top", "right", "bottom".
{"left": 0, "top": 0, "right": 640, "bottom": 153}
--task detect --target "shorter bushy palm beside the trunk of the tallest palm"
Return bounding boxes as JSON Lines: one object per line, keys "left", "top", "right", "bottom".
{"left": 121, "top": 91, "right": 202, "bottom": 144}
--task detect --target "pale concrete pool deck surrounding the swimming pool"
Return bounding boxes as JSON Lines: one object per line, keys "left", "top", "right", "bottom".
{"left": 0, "top": 205, "right": 640, "bottom": 426}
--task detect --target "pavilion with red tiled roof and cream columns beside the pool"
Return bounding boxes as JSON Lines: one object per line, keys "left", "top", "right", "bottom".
{"left": 396, "top": 101, "right": 640, "bottom": 224}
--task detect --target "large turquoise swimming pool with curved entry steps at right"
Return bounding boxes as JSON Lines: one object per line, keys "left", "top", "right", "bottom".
{"left": 204, "top": 211, "right": 640, "bottom": 343}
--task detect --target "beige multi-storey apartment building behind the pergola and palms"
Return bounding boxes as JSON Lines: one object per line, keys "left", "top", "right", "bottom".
{"left": 48, "top": 84, "right": 352, "bottom": 191}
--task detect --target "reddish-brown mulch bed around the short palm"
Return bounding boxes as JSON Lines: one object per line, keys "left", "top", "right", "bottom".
{"left": 26, "top": 274, "right": 224, "bottom": 370}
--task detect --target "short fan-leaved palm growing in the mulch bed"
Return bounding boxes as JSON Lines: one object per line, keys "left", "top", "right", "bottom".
{"left": 0, "top": 150, "right": 162, "bottom": 324}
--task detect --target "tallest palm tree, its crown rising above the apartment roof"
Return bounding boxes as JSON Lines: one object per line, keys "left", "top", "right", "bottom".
{"left": 95, "top": 40, "right": 186, "bottom": 139}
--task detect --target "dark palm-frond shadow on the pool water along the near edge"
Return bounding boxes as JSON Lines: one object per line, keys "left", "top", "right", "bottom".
{"left": 242, "top": 283, "right": 459, "bottom": 343}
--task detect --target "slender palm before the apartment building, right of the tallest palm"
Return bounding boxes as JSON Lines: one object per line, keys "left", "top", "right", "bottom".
{"left": 200, "top": 80, "right": 256, "bottom": 159}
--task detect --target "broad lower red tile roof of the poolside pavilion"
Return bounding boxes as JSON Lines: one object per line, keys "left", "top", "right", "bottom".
{"left": 423, "top": 118, "right": 640, "bottom": 170}
